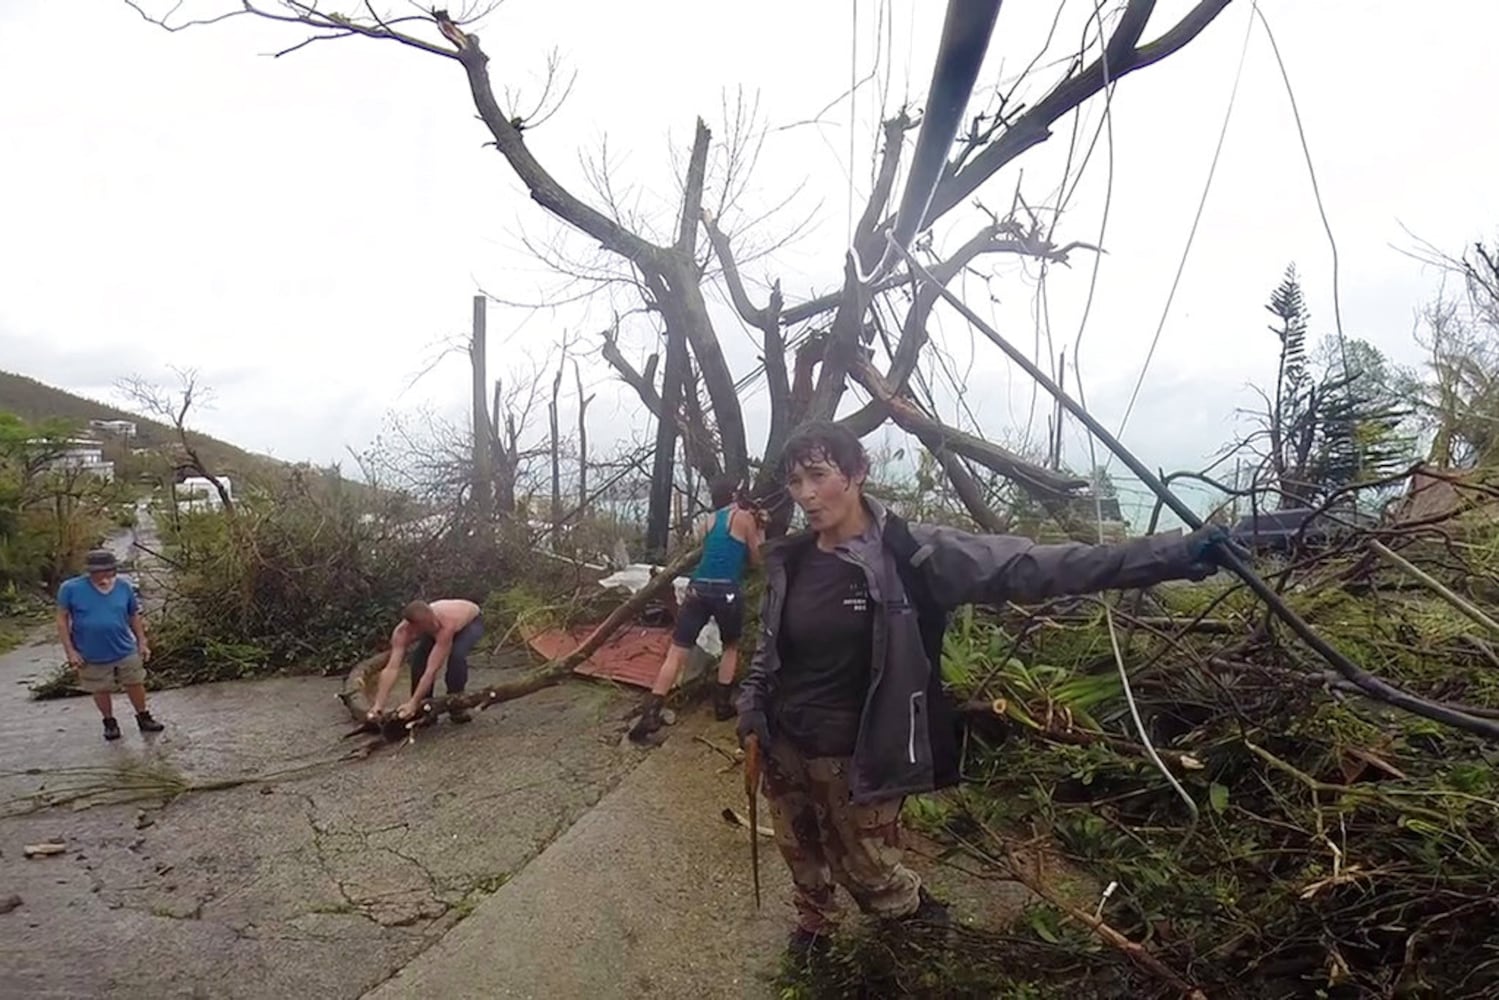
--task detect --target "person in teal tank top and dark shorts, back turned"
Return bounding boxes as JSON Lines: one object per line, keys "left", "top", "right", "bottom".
{"left": 630, "top": 477, "right": 764, "bottom": 742}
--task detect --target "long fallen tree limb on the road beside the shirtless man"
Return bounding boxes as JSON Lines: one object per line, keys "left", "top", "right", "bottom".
{"left": 339, "top": 546, "right": 703, "bottom": 739}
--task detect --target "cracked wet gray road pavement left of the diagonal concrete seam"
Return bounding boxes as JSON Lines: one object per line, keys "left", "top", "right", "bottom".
{"left": 0, "top": 643, "right": 640, "bottom": 1000}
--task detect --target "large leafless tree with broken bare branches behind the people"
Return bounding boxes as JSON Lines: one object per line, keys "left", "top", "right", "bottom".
{"left": 124, "top": 0, "right": 1229, "bottom": 539}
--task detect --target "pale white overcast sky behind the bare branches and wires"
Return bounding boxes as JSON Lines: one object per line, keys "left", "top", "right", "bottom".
{"left": 0, "top": 0, "right": 1499, "bottom": 524}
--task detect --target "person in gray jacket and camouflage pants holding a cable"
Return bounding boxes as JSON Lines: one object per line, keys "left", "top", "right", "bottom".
{"left": 739, "top": 423, "right": 1225, "bottom": 955}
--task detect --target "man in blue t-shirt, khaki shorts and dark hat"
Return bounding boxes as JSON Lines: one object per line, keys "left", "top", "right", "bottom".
{"left": 57, "top": 549, "right": 163, "bottom": 739}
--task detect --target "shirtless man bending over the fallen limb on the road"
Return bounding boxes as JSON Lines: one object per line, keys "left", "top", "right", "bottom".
{"left": 369, "top": 598, "right": 484, "bottom": 723}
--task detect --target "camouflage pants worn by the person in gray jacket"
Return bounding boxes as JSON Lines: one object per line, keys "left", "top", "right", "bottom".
{"left": 763, "top": 739, "right": 920, "bottom": 933}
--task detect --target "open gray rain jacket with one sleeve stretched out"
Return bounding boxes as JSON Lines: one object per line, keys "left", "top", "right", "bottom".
{"left": 739, "top": 498, "right": 1214, "bottom": 802}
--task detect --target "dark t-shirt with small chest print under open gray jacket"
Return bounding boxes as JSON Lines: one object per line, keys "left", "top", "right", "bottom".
{"left": 775, "top": 546, "right": 874, "bottom": 757}
